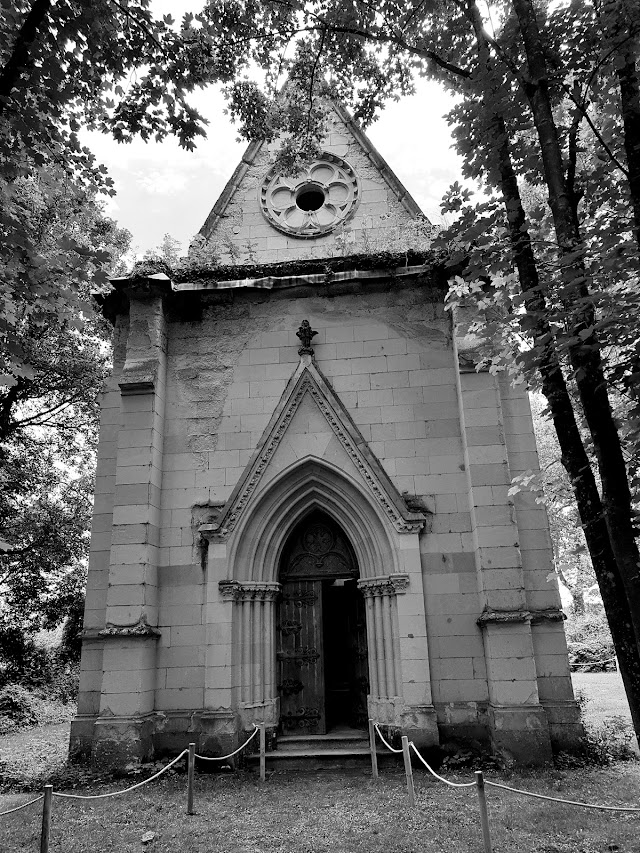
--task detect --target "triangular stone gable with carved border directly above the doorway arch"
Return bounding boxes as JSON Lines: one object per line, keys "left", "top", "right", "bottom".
{"left": 201, "top": 357, "right": 426, "bottom": 537}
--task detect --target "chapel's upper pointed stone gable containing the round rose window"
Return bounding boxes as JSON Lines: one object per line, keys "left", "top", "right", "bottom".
{"left": 195, "top": 103, "right": 426, "bottom": 265}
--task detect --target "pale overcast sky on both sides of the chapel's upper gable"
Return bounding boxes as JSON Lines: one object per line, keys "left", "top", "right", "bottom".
{"left": 84, "top": 20, "right": 460, "bottom": 254}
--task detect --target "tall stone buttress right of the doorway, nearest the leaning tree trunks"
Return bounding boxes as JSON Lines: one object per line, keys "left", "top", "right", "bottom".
{"left": 458, "top": 352, "right": 551, "bottom": 763}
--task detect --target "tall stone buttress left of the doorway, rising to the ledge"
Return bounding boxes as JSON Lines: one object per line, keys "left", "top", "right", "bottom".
{"left": 92, "top": 280, "right": 170, "bottom": 764}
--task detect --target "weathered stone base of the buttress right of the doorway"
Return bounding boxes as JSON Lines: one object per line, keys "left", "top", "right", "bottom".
{"left": 489, "top": 704, "right": 552, "bottom": 765}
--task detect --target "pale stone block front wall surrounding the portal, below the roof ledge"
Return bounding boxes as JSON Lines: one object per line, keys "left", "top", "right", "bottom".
{"left": 74, "top": 282, "right": 577, "bottom": 755}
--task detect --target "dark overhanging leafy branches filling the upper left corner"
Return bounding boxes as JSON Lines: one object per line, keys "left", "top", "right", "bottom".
{"left": 0, "top": 0, "right": 296, "bottom": 386}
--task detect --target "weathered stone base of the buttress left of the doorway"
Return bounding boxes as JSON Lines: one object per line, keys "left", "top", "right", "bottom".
{"left": 91, "top": 713, "right": 157, "bottom": 767}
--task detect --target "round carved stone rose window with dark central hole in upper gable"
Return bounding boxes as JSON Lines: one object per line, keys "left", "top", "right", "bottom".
{"left": 260, "top": 153, "right": 359, "bottom": 238}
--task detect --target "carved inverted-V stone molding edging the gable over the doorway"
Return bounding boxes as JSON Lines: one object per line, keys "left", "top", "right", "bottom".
{"left": 200, "top": 357, "right": 426, "bottom": 537}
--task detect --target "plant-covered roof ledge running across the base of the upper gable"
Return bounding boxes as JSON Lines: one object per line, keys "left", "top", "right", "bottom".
{"left": 129, "top": 250, "right": 445, "bottom": 283}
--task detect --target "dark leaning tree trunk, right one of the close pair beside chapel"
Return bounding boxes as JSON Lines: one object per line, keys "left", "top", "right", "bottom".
{"left": 512, "top": 0, "right": 640, "bottom": 645}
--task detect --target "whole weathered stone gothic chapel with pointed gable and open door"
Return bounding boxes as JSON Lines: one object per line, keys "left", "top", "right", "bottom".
{"left": 71, "top": 104, "right": 582, "bottom": 764}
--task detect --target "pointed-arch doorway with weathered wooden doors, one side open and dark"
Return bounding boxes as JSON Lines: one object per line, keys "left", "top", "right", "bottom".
{"left": 276, "top": 510, "right": 369, "bottom": 734}
